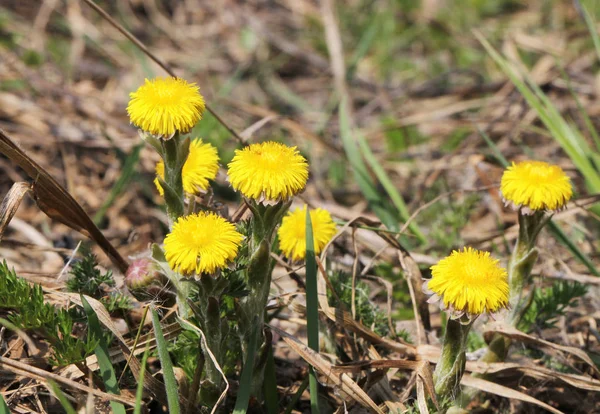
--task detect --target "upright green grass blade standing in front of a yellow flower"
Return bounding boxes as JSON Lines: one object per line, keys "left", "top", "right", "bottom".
{"left": 306, "top": 208, "right": 319, "bottom": 414}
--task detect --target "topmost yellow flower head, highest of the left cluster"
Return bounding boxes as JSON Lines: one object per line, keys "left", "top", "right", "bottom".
{"left": 127, "top": 77, "right": 205, "bottom": 138}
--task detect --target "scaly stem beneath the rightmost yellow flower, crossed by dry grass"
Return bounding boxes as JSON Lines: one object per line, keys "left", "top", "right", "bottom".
{"left": 480, "top": 211, "right": 551, "bottom": 363}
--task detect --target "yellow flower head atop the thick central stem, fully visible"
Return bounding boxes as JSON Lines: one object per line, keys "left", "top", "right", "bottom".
{"left": 229, "top": 142, "right": 308, "bottom": 202}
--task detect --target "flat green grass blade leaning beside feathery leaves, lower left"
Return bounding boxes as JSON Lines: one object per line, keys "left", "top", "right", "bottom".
{"left": 81, "top": 295, "right": 125, "bottom": 414}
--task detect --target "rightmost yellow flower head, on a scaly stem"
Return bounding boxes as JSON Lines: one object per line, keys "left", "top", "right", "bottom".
{"left": 500, "top": 161, "right": 573, "bottom": 214}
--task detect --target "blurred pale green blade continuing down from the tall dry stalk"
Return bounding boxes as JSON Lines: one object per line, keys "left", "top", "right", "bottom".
{"left": 339, "top": 100, "right": 400, "bottom": 231}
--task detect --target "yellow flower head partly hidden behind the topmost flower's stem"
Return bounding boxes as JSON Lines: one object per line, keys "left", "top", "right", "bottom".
{"left": 154, "top": 139, "right": 219, "bottom": 196}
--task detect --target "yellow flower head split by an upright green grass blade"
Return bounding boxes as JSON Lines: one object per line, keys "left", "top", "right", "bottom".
{"left": 277, "top": 205, "right": 336, "bottom": 260}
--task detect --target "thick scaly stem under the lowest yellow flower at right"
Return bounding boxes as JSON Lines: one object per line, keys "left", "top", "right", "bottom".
{"left": 433, "top": 319, "right": 473, "bottom": 400}
